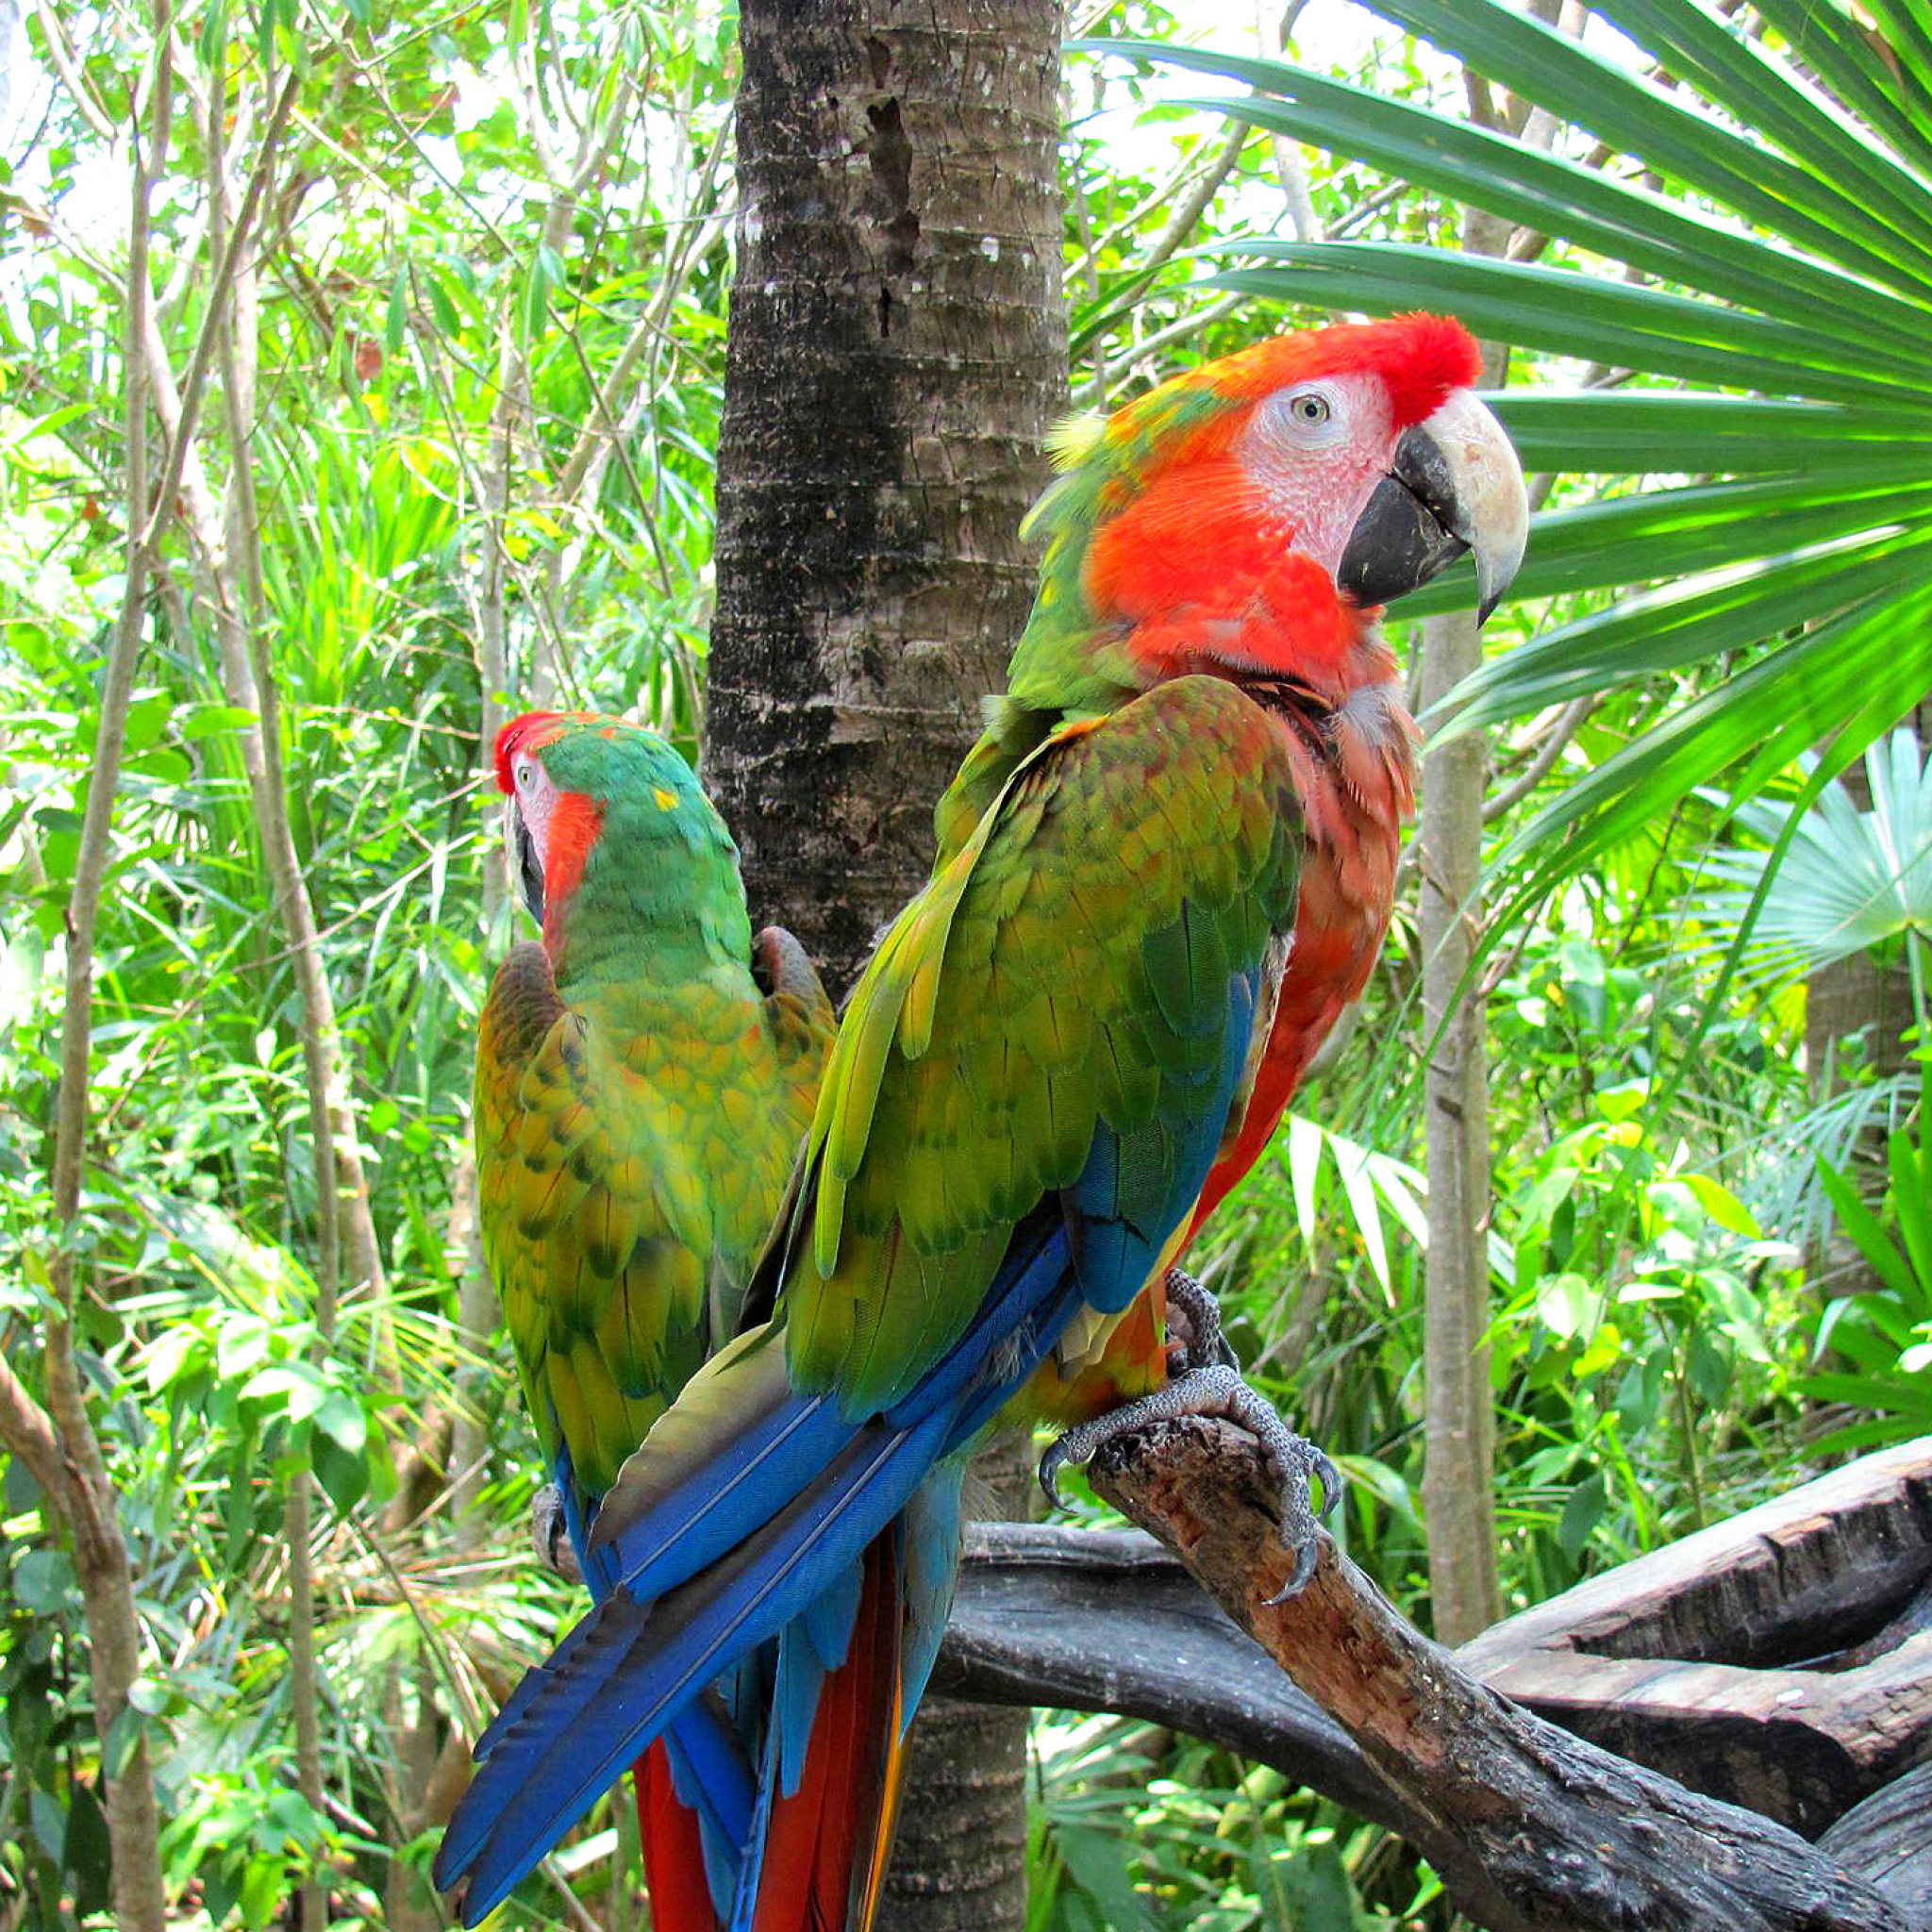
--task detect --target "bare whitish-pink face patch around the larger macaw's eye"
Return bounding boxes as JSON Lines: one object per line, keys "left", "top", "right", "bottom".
{"left": 1235, "top": 375, "right": 1393, "bottom": 575}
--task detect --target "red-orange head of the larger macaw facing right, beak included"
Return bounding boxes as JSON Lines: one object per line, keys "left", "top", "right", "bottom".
{"left": 1012, "top": 315, "right": 1528, "bottom": 695}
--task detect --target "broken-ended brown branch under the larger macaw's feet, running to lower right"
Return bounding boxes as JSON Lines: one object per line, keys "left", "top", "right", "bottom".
{"left": 1090, "top": 1418, "right": 1915, "bottom": 1932}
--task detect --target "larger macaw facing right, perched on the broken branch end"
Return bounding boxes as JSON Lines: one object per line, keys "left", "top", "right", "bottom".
{"left": 437, "top": 315, "right": 1526, "bottom": 1932}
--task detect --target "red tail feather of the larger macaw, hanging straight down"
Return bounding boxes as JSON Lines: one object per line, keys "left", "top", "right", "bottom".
{"left": 752, "top": 1530, "right": 902, "bottom": 1932}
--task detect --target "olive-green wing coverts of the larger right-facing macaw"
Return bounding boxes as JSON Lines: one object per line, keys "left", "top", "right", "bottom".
{"left": 782, "top": 678, "right": 1300, "bottom": 1416}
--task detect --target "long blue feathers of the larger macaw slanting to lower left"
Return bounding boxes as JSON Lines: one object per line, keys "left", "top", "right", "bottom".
{"left": 433, "top": 1202, "right": 1078, "bottom": 1926}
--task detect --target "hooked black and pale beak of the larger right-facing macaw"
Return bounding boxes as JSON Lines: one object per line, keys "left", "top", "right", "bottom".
{"left": 1335, "top": 389, "right": 1530, "bottom": 625}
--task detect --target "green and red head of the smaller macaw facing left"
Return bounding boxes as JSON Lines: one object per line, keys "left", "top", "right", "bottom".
{"left": 496, "top": 711, "right": 741, "bottom": 942}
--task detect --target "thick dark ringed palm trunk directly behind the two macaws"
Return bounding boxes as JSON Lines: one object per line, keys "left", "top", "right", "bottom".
{"left": 706, "top": 0, "right": 1066, "bottom": 1932}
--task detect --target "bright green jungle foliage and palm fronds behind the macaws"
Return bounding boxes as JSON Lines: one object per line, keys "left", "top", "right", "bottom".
{"left": 0, "top": 0, "right": 1932, "bottom": 1932}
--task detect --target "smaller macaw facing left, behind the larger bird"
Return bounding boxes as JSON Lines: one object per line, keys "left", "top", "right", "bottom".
{"left": 474, "top": 711, "right": 833, "bottom": 1932}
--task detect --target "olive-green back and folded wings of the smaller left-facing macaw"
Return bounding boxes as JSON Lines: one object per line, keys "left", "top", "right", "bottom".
{"left": 475, "top": 935, "right": 831, "bottom": 1497}
